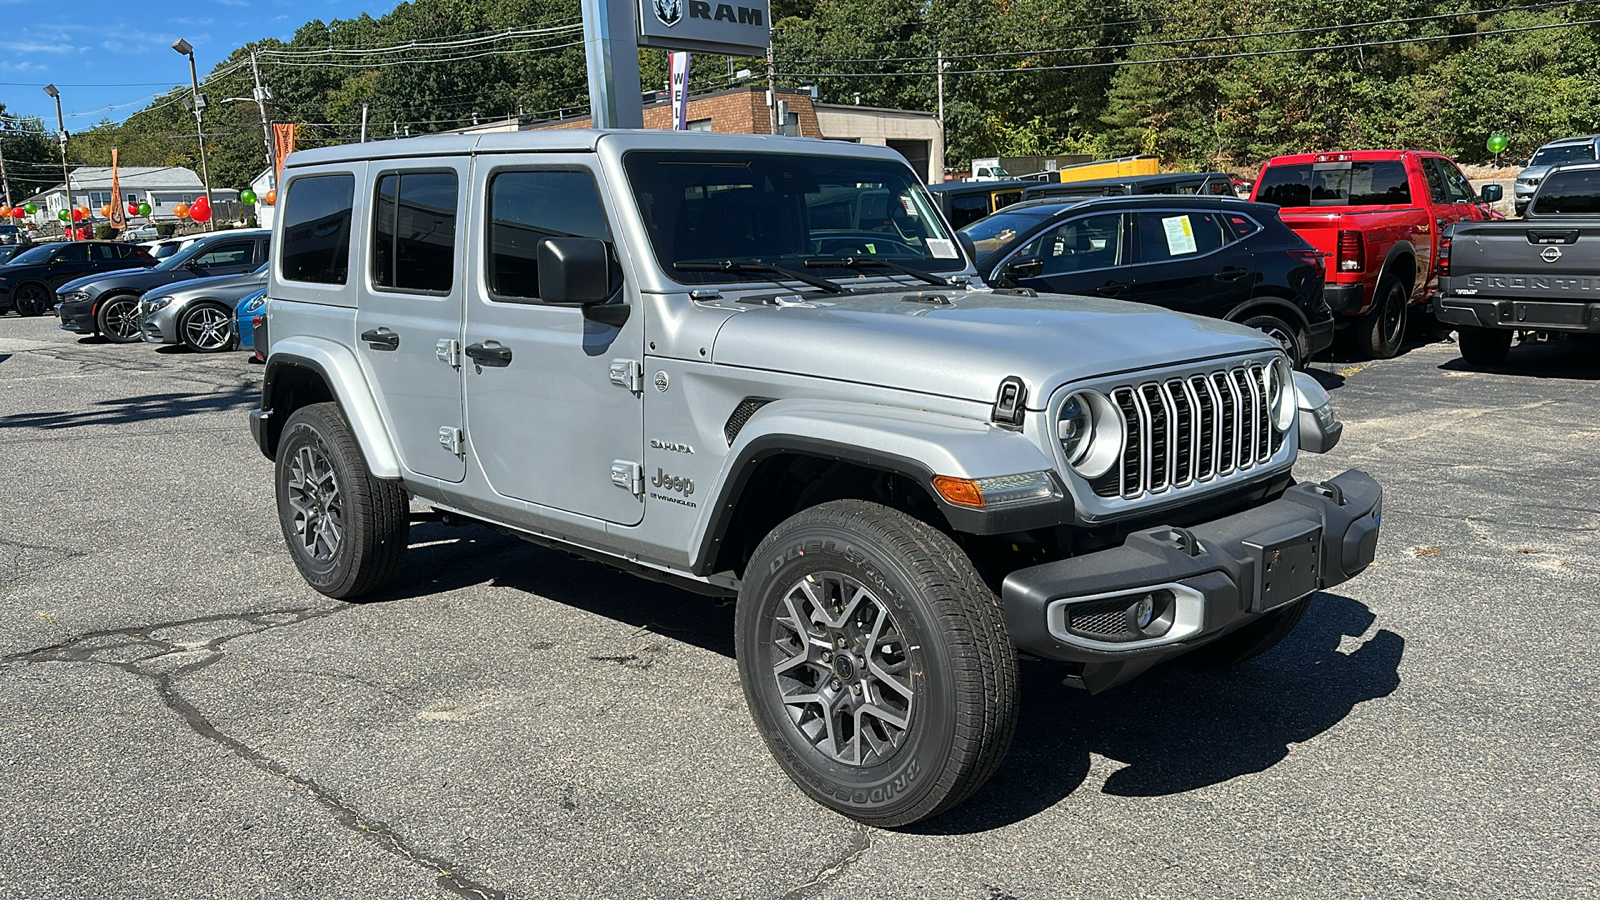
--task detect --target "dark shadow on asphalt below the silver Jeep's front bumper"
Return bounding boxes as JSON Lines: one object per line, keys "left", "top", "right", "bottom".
{"left": 914, "top": 594, "right": 1405, "bottom": 834}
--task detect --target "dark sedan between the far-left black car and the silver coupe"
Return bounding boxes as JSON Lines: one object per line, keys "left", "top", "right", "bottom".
{"left": 56, "top": 231, "right": 272, "bottom": 344}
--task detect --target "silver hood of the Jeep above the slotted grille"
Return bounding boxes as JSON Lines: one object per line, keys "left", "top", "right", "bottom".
{"left": 712, "top": 288, "right": 1278, "bottom": 408}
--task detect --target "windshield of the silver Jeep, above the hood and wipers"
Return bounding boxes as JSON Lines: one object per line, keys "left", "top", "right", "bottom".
{"left": 624, "top": 151, "right": 966, "bottom": 283}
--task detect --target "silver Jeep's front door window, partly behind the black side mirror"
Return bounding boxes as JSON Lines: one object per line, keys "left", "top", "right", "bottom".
{"left": 488, "top": 170, "right": 611, "bottom": 303}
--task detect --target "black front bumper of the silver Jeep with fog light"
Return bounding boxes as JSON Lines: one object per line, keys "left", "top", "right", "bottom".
{"left": 1000, "top": 469, "right": 1382, "bottom": 690}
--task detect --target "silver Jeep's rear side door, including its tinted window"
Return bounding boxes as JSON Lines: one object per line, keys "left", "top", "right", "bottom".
{"left": 355, "top": 159, "right": 469, "bottom": 482}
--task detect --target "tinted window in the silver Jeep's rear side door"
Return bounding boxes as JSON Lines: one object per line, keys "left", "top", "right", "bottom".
{"left": 373, "top": 171, "right": 456, "bottom": 293}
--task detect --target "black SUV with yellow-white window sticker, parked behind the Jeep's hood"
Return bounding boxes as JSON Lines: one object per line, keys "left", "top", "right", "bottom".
{"left": 962, "top": 195, "right": 1333, "bottom": 367}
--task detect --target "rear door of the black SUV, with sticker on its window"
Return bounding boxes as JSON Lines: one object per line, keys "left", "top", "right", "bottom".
{"left": 1120, "top": 208, "right": 1259, "bottom": 319}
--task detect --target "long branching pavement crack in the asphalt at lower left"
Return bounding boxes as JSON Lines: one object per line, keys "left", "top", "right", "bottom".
{"left": 0, "top": 605, "right": 506, "bottom": 900}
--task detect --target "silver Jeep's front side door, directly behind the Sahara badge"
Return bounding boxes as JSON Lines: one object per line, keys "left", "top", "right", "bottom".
{"left": 462, "top": 154, "right": 640, "bottom": 525}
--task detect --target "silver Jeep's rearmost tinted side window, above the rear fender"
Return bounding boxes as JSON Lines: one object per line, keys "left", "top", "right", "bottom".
{"left": 280, "top": 175, "right": 355, "bottom": 285}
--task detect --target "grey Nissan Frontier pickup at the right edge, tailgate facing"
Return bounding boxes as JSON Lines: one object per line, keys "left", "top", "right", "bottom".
{"left": 1432, "top": 163, "right": 1600, "bottom": 365}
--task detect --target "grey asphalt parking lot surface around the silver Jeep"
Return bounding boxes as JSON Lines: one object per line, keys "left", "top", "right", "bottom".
{"left": 0, "top": 315, "right": 1600, "bottom": 900}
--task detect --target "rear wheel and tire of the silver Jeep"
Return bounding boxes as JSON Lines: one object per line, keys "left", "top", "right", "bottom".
{"left": 274, "top": 404, "right": 411, "bottom": 599}
